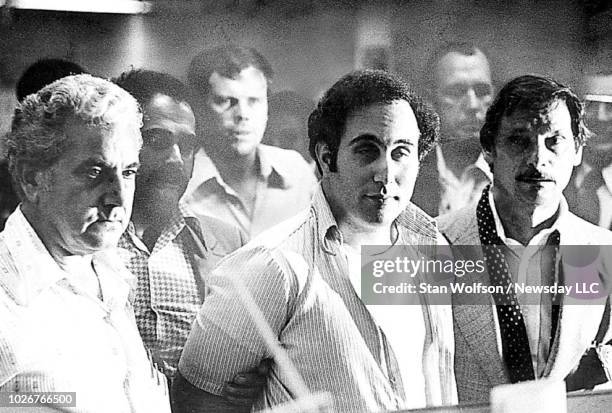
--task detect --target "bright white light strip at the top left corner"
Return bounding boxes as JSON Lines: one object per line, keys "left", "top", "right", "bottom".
{"left": 0, "top": 0, "right": 152, "bottom": 14}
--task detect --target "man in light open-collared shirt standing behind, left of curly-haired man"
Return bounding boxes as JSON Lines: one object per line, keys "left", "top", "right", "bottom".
{"left": 184, "top": 45, "right": 316, "bottom": 238}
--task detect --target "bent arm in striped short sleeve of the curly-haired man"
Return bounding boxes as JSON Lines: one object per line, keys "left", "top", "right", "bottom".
{"left": 173, "top": 249, "right": 296, "bottom": 411}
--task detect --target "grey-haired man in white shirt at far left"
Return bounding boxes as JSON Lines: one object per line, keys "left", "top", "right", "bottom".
{"left": 0, "top": 75, "right": 169, "bottom": 412}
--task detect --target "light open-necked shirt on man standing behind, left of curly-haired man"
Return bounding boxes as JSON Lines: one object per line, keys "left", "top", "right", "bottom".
{"left": 184, "top": 144, "right": 316, "bottom": 238}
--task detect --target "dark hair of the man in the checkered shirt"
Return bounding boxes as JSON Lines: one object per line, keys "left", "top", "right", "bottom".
{"left": 113, "top": 69, "right": 189, "bottom": 107}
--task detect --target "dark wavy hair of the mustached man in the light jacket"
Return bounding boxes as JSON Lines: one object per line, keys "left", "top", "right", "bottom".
{"left": 480, "top": 75, "right": 590, "bottom": 152}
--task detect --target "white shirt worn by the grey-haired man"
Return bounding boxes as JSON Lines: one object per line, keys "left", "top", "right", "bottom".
{"left": 0, "top": 208, "right": 170, "bottom": 413}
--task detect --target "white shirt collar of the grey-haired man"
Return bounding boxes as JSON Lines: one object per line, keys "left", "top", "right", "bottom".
{"left": 0, "top": 207, "right": 129, "bottom": 305}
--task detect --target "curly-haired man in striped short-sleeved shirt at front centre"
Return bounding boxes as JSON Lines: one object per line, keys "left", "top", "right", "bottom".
{"left": 172, "top": 71, "right": 456, "bottom": 412}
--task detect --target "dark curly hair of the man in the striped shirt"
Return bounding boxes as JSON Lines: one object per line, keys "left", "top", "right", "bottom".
{"left": 308, "top": 70, "right": 440, "bottom": 172}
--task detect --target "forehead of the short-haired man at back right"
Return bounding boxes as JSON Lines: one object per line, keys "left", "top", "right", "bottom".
{"left": 436, "top": 50, "right": 491, "bottom": 87}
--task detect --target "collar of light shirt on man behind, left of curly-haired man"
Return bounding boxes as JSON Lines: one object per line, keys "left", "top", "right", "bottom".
{"left": 185, "top": 144, "right": 292, "bottom": 195}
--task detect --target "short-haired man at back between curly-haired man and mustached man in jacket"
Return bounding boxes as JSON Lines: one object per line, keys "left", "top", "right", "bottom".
{"left": 412, "top": 42, "right": 493, "bottom": 216}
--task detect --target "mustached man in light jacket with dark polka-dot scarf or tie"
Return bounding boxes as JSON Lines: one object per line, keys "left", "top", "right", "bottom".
{"left": 438, "top": 76, "right": 612, "bottom": 402}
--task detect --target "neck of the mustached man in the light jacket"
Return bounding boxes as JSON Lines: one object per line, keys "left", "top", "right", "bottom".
{"left": 493, "top": 190, "right": 559, "bottom": 245}
